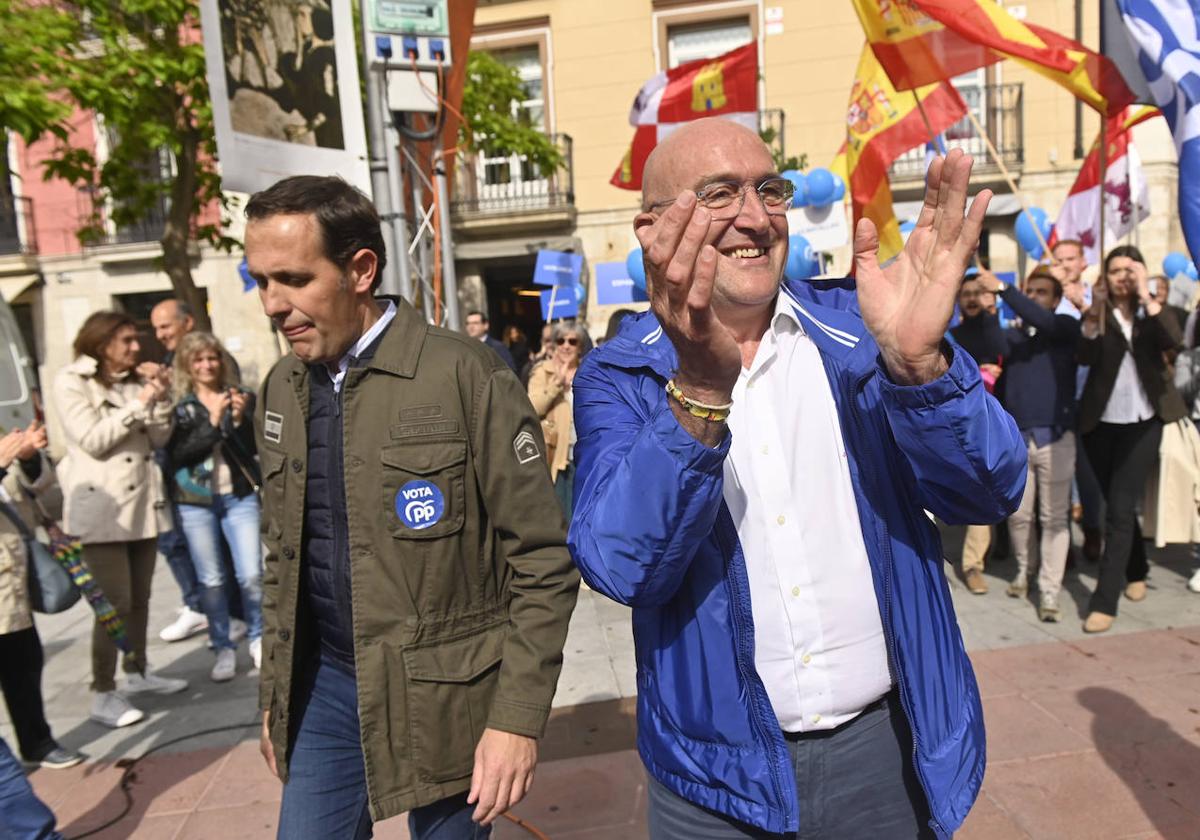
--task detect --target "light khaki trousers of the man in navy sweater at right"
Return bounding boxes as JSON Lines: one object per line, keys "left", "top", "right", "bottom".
{"left": 1008, "top": 432, "right": 1075, "bottom": 600}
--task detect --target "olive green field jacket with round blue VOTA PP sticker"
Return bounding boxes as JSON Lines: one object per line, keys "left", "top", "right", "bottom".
{"left": 257, "top": 301, "right": 580, "bottom": 821}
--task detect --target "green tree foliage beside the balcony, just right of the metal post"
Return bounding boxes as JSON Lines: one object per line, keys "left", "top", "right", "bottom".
{"left": 458, "top": 52, "right": 563, "bottom": 178}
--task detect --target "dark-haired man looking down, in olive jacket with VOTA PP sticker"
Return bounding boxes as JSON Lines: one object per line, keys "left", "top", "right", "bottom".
{"left": 246, "top": 176, "right": 578, "bottom": 840}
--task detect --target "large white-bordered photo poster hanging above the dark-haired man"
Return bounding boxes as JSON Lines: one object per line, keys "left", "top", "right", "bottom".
{"left": 200, "top": 0, "right": 371, "bottom": 196}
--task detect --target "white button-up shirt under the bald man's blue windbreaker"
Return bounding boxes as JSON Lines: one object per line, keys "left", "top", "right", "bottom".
{"left": 725, "top": 293, "right": 892, "bottom": 732}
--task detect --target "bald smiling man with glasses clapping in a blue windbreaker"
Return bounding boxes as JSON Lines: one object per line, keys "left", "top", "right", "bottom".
{"left": 570, "top": 119, "right": 1026, "bottom": 840}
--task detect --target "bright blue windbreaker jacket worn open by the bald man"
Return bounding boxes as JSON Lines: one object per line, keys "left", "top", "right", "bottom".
{"left": 570, "top": 280, "right": 1026, "bottom": 836}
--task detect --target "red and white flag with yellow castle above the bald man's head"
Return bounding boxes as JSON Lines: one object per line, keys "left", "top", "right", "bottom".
{"left": 610, "top": 43, "right": 758, "bottom": 190}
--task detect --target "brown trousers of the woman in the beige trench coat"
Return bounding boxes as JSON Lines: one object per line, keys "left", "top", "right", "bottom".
{"left": 83, "top": 540, "right": 158, "bottom": 691}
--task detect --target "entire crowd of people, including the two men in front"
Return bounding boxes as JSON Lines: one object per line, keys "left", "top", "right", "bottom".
{"left": 0, "top": 131, "right": 1200, "bottom": 840}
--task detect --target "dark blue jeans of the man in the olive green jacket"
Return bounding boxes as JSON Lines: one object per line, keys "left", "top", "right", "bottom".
{"left": 277, "top": 658, "right": 492, "bottom": 840}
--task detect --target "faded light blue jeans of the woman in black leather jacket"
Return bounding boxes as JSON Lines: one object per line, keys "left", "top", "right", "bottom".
{"left": 179, "top": 493, "right": 263, "bottom": 650}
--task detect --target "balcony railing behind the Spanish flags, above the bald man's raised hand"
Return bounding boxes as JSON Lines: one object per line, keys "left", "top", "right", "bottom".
{"left": 892, "top": 82, "right": 1025, "bottom": 180}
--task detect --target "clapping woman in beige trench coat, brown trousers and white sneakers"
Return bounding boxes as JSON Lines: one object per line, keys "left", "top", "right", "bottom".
{"left": 54, "top": 312, "right": 187, "bottom": 727}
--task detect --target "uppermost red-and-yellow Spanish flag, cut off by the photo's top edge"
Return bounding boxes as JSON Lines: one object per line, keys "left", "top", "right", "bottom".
{"left": 853, "top": 0, "right": 1134, "bottom": 116}
